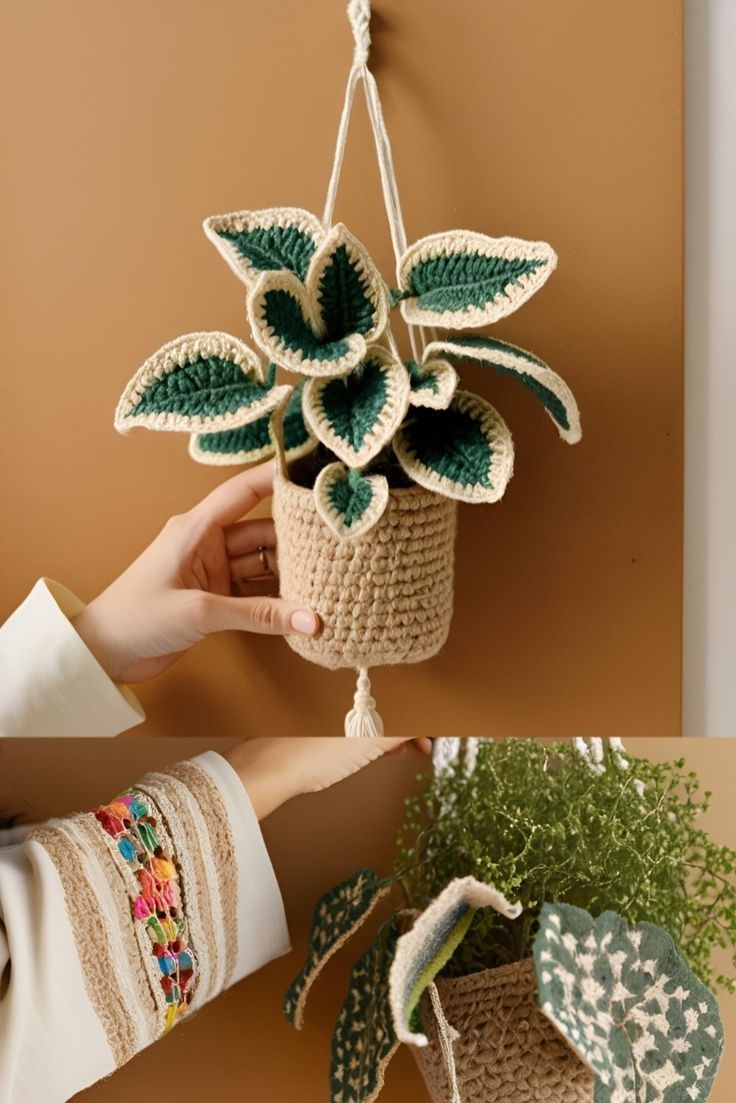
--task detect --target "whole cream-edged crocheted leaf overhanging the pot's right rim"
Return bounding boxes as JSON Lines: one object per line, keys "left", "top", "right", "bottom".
{"left": 394, "top": 390, "right": 513, "bottom": 502}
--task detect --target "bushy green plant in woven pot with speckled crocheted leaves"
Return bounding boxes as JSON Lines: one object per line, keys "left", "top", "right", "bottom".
{"left": 285, "top": 740, "right": 736, "bottom": 1103}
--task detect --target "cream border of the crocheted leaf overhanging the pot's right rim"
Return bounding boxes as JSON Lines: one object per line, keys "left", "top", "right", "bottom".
{"left": 394, "top": 390, "right": 514, "bottom": 503}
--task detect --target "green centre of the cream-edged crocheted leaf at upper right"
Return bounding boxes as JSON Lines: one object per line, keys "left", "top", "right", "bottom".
{"left": 408, "top": 253, "right": 547, "bottom": 313}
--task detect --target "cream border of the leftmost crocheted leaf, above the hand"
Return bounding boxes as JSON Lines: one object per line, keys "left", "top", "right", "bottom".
{"left": 114, "top": 332, "right": 290, "bottom": 435}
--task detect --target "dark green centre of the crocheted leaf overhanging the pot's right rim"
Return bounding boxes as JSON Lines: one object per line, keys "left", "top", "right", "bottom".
{"left": 403, "top": 406, "right": 493, "bottom": 489}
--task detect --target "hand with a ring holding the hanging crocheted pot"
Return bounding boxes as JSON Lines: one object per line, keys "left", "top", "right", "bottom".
{"left": 72, "top": 463, "right": 320, "bottom": 682}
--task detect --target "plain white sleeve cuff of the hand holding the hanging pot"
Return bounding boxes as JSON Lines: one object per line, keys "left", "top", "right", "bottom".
{"left": 0, "top": 578, "right": 146, "bottom": 738}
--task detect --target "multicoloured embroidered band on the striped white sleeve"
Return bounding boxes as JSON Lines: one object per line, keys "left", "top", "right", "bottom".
{"left": 94, "top": 790, "right": 198, "bottom": 1032}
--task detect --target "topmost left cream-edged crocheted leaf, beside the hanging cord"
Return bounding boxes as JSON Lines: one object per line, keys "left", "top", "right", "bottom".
{"left": 203, "top": 207, "right": 324, "bottom": 287}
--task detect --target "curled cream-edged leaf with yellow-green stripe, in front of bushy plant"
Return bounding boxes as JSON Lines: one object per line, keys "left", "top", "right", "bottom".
{"left": 388, "top": 877, "right": 522, "bottom": 1046}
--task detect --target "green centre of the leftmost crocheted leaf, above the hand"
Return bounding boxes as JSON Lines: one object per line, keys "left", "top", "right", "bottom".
{"left": 126, "top": 356, "right": 276, "bottom": 417}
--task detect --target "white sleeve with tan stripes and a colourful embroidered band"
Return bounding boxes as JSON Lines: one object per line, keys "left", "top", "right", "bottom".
{"left": 0, "top": 752, "right": 289, "bottom": 1103}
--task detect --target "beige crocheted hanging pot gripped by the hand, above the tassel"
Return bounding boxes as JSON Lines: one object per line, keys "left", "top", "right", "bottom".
{"left": 273, "top": 474, "right": 457, "bottom": 670}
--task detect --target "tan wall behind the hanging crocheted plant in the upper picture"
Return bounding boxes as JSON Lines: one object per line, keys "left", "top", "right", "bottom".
{"left": 0, "top": 0, "right": 682, "bottom": 736}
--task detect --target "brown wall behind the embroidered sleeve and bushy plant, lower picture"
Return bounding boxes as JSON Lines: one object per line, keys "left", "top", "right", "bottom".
{"left": 0, "top": 739, "right": 736, "bottom": 1103}
